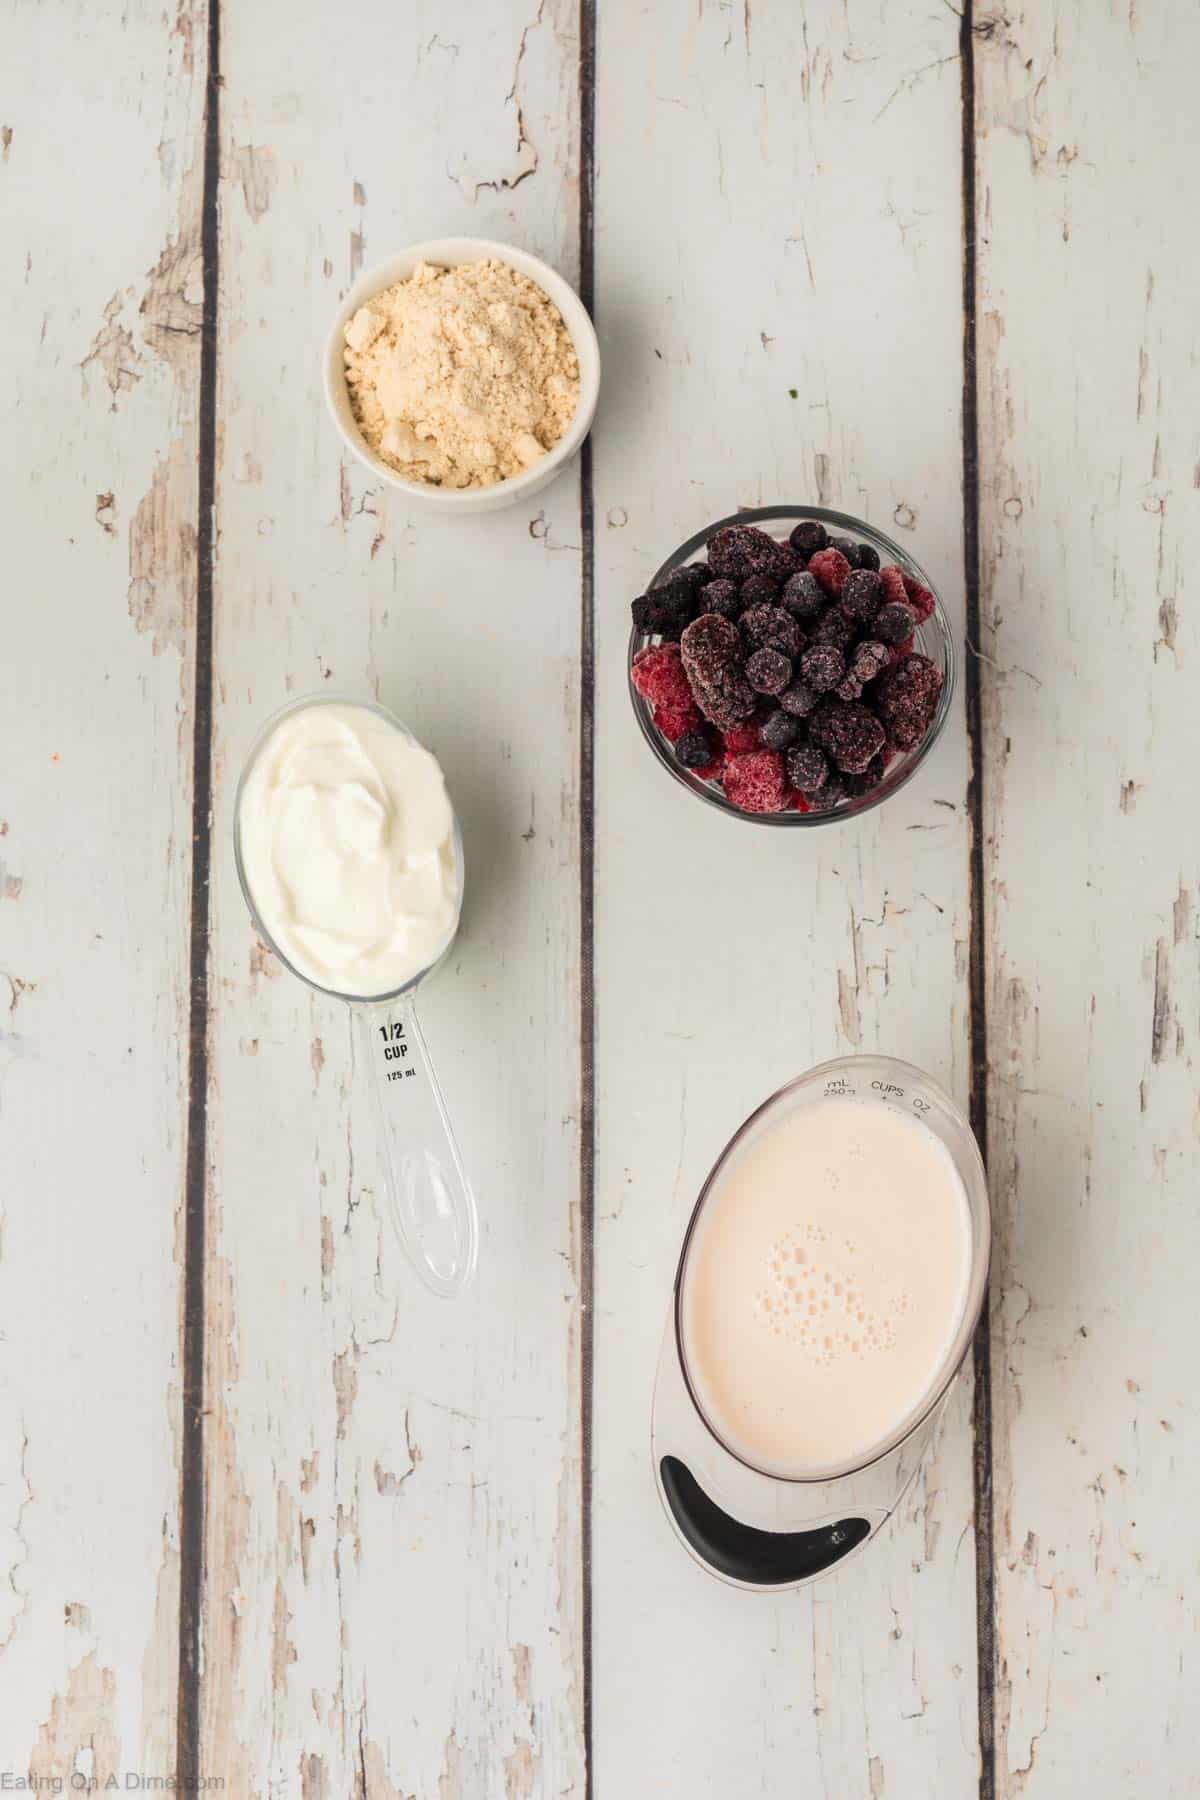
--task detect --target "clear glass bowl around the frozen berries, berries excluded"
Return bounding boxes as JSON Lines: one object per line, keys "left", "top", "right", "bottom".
{"left": 628, "top": 506, "right": 955, "bottom": 830}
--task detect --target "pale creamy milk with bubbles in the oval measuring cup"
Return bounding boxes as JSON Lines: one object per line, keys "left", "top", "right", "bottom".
{"left": 680, "top": 1098, "right": 972, "bottom": 1478}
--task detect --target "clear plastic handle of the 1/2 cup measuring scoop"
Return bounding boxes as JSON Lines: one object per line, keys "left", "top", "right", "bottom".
{"left": 354, "top": 997, "right": 479, "bottom": 1300}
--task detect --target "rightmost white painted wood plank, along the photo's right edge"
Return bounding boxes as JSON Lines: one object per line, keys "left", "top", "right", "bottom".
{"left": 977, "top": 0, "right": 1200, "bottom": 1800}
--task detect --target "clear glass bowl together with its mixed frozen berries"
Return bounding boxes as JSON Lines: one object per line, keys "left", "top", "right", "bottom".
{"left": 630, "top": 506, "right": 955, "bottom": 826}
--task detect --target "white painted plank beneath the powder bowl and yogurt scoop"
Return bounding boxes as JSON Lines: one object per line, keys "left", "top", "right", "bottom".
{"left": 203, "top": 4, "right": 583, "bottom": 1800}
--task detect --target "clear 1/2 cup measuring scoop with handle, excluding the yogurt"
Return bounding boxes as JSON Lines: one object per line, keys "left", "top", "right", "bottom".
{"left": 234, "top": 693, "right": 479, "bottom": 1300}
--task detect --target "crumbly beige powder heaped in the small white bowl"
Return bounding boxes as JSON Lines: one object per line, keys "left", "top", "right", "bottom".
{"left": 345, "top": 259, "right": 579, "bottom": 488}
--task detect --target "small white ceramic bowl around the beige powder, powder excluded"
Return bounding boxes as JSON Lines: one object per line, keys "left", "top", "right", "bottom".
{"left": 324, "top": 238, "right": 599, "bottom": 513}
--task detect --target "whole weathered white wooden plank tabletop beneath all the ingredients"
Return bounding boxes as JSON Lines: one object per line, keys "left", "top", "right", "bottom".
{"left": 0, "top": 0, "right": 1200, "bottom": 1800}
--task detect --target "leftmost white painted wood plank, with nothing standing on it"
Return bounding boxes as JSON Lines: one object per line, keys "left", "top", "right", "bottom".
{"left": 0, "top": 4, "right": 201, "bottom": 1791}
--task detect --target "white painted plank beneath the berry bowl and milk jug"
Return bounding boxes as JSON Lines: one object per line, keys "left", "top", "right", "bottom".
{"left": 594, "top": 4, "right": 977, "bottom": 1800}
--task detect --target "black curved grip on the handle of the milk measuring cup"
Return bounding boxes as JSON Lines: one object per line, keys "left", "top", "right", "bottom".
{"left": 658, "top": 1456, "right": 871, "bottom": 1588}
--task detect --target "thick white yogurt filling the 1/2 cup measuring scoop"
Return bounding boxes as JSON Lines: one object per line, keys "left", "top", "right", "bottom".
{"left": 237, "top": 702, "right": 462, "bottom": 999}
